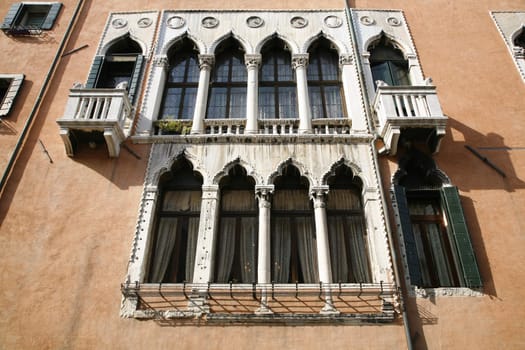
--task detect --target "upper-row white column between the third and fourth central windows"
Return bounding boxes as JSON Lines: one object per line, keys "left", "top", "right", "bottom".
{"left": 292, "top": 53, "right": 312, "bottom": 134}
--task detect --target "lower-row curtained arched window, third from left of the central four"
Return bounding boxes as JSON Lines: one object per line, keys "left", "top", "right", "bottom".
{"left": 271, "top": 164, "right": 319, "bottom": 283}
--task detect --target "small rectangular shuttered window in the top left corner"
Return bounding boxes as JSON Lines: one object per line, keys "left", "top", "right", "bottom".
{"left": 0, "top": 2, "right": 62, "bottom": 34}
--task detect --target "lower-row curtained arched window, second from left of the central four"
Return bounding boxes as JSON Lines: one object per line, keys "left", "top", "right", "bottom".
{"left": 215, "top": 165, "right": 257, "bottom": 283}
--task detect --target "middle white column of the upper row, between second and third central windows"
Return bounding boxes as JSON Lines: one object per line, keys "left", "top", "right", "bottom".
{"left": 244, "top": 54, "right": 261, "bottom": 134}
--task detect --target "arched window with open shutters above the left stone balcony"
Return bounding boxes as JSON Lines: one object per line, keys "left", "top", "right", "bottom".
{"left": 86, "top": 36, "right": 144, "bottom": 102}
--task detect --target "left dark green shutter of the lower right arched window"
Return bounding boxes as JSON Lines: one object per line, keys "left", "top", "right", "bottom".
{"left": 394, "top": 185, "right": 422, "bottom": 286}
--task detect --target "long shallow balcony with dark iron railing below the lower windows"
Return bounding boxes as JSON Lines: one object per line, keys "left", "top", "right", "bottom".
{"left": 121, "top": 282, "right": 397, "bottom": 324}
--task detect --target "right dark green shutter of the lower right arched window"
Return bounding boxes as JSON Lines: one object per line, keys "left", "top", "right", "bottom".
{"left": 441, "top": 186, "right": 482, "bottom": 287}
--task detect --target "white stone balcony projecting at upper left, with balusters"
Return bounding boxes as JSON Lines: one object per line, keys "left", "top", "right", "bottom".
{"left": 57, "top": 88, "right": 132, "bottom": 157}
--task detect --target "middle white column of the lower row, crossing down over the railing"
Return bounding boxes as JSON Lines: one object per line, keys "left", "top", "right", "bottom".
{"left": 255, "top": 185, "right": 274, "bottom": 314}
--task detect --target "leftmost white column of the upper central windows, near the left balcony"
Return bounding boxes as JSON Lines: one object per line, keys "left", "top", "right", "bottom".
{"left": 136, "top": 56, "right": 169, "bottom": 136}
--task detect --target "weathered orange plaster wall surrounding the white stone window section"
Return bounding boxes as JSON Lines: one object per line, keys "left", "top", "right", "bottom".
{"left": 0, "top": 0, "right": 525, "bottom": 349}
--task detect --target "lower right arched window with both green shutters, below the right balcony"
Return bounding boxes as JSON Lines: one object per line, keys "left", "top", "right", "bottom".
{"left": 394, "top": 149, "right": 482, "bottom": 288}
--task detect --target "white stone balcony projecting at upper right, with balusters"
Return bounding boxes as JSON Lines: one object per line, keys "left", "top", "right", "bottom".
{"left": 374, "top": 83, "right": 448, "bottom": 155}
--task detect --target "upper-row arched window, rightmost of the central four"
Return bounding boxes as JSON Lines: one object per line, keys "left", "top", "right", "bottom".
{"left": 308, "top": 38, "right": 344, "bottom": 118}
